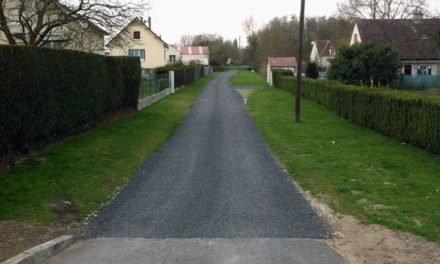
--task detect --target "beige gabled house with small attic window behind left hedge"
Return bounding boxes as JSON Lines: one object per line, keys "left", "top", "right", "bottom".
{"left": 106, "top": 18, "right": 169, "bottom": 69}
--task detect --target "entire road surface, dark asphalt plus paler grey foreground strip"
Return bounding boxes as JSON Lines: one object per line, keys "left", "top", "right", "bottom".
{"left": 45, "top": 72, "right": 344, "bottom": 263}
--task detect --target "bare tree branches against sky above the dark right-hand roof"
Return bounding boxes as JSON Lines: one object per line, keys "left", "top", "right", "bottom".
{"left": 337, "top": 0, "right": 429, "bottom": 20}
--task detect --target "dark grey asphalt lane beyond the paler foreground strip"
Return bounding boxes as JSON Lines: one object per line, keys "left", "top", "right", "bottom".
{"left": 88, "top": 72, "right": 328, "bottom": 239}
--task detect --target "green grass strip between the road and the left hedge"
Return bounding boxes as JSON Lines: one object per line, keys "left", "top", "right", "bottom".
{"left": 0, "top": 73, "right": 217, "bottom": 224}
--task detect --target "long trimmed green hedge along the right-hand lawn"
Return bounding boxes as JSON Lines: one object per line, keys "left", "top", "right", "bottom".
{"left": 273, "top": 72, "right": 440, "bottom": 153}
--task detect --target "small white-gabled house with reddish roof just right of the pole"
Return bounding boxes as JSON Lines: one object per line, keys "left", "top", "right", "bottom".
{"left": 310, "top": 39, "right": 337, "bottom": 69}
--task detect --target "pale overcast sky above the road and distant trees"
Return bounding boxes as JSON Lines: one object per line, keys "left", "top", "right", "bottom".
{"left": 149, "top": 0, "right": 440, "bottom": 46}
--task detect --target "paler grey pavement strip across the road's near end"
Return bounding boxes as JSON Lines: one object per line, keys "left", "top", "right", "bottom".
{"left": 43, "top": 238, "right": 347, "bottom": 264}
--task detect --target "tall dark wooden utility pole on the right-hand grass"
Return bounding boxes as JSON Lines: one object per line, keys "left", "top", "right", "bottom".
{"left": 295, "top": 0, "right": 305, "bottom": 122}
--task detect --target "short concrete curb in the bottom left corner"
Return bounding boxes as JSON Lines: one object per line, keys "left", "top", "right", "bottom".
{"left": 0, "top": 235, "right": 77, "bottom": 264}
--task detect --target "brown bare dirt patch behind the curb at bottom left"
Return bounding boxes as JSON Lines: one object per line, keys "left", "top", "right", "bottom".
{"left": 0, "top": 221, "right": 83, "bottom": 262}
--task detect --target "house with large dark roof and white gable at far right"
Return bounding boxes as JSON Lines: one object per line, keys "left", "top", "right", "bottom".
{"left": 350, "top": 12, "right": 440, "bottom": 76}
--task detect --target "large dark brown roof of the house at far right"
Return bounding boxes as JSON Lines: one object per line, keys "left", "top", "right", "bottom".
{"left": 356, "top": 19, "right": 440, "bottom": 60}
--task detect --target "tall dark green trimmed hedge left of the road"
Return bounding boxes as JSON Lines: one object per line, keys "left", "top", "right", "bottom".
{"left": 0, "top": 45, "right": 141, "bottom": 158}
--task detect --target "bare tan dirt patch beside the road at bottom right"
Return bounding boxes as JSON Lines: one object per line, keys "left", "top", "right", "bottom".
{"left": 295, "top": 184, "right": 440, "bottom": 264}
